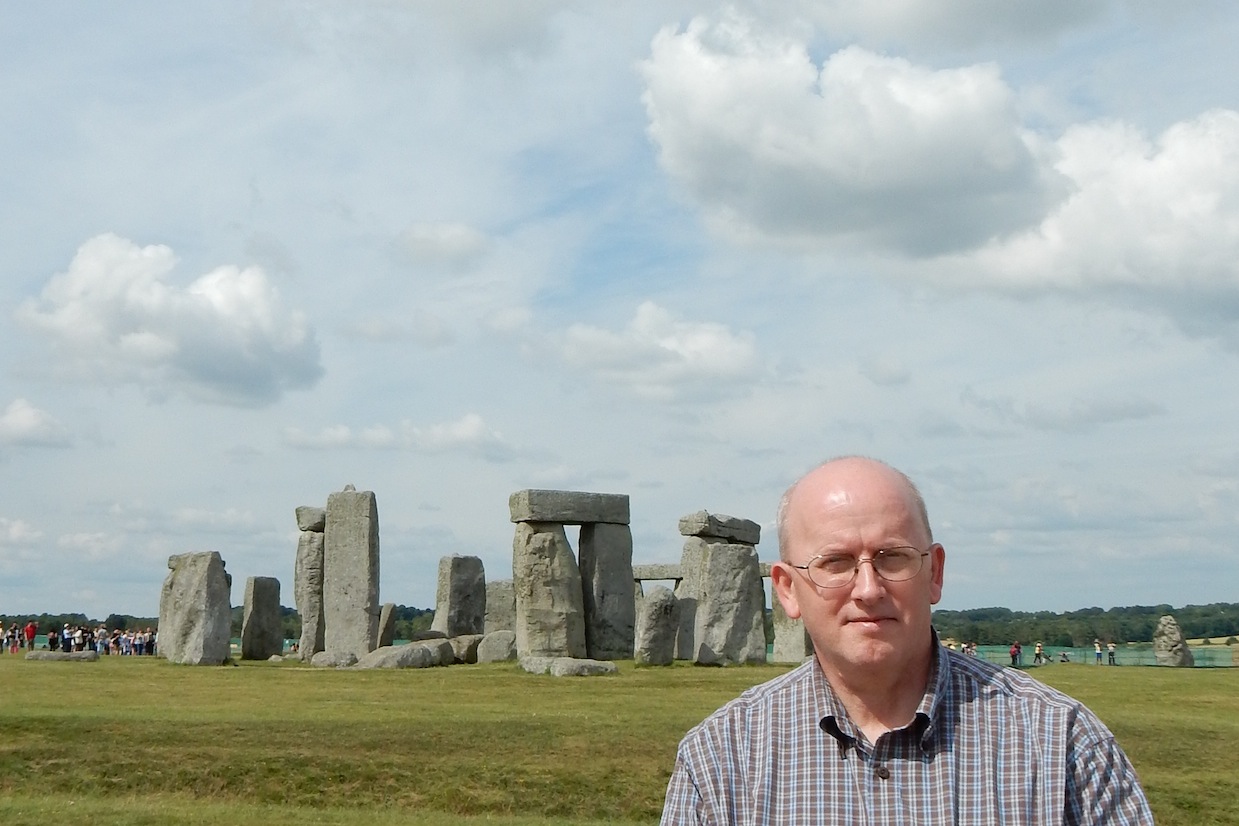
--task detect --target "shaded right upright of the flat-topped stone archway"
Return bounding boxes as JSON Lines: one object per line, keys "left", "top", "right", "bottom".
{"left": 580, "top": 523, "right": 637, "bottom": 660}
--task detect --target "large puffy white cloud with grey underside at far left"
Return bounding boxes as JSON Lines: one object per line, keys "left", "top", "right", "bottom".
{"left": 17, "top": 234, "right": 322, "bottom": 406}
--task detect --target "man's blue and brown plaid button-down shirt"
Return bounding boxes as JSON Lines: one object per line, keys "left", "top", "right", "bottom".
{"left": 662, "top": 641, "right": 1154, "bottom": 826}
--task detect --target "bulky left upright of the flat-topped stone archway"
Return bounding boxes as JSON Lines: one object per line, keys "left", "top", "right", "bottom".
{"left": 512, "top": 523, "right": 586, "bottom": 658}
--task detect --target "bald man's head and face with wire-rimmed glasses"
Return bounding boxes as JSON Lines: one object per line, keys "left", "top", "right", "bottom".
{"left": 772, "top": 459, "right": 945, "bottom": 680}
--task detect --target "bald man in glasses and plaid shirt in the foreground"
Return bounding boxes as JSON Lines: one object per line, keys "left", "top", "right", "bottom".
{"left": 663, "top": 457, "right": 1152, "bottom": 826}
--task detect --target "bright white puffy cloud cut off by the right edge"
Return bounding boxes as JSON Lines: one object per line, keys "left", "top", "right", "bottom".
{"left": 937, "top": 110, "right": 1239, "bottom": 332}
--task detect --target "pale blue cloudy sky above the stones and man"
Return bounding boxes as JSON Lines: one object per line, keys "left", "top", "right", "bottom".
{"left": 0, "top": 0, "right": 1239, "bottom": 618}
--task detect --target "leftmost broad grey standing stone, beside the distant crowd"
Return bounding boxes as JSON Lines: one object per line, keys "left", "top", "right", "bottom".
{"left": 159, "top": 551, "right": 232, "bottom": 665}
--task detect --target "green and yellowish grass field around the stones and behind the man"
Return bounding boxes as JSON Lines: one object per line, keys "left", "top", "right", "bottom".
{"left": 0, "top": 655, "right": 1239, "bottom": 826}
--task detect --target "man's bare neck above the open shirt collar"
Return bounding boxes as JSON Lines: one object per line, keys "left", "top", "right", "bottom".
{"left": 818, "top": 645, "right": 933, "bottom": 743}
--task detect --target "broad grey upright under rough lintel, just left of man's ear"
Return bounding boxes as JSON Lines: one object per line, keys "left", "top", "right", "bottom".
{"left": 693, "top": 542, "right": 766, "bottom": 665}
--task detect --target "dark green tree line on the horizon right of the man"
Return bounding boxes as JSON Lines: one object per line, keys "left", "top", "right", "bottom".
{"left": 933, "top": 602, "right": 1239, "bottom": 648}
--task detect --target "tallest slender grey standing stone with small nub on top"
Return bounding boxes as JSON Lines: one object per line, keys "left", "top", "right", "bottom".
{"left": 322, "top": 485, "right": 379, "bottom": 658}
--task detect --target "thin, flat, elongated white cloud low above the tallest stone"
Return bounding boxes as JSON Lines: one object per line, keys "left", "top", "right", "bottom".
{"left": 284, "top": 412, "right": 515, "bottom": 462}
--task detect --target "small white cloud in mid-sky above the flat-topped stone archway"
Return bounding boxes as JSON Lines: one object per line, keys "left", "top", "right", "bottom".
{"left": 560, "top": 301, "right": 758, "bottom": 399}
